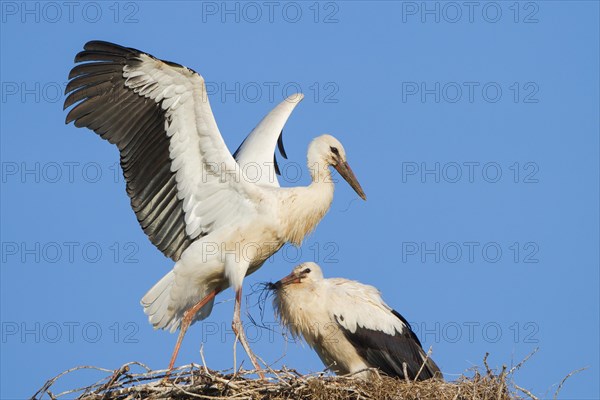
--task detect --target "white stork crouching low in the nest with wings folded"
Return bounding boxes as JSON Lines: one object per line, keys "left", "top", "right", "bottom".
{"left": 270, "top": 262, "right": 442, "bottom": 380}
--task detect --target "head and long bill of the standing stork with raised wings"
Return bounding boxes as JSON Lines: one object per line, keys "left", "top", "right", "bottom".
{"left": 308, "top": 135, "right": 367, "bottom": 200}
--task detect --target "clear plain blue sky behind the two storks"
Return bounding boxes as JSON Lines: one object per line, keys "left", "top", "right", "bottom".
{"left": 0, "top": 1, "right": 600, "bottom": 399}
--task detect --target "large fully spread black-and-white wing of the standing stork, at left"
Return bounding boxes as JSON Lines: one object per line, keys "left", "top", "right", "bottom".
{"left": 64, "top": 41, "right": 260, "bottom": 260}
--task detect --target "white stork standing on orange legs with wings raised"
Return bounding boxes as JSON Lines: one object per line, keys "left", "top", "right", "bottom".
{"left": 64, "top": 41, "right": 366, "bottom": 376}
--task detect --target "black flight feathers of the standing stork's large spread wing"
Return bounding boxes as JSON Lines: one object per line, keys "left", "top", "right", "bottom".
{"left": 64, "top": 41, "right": 193, "bottom": 261}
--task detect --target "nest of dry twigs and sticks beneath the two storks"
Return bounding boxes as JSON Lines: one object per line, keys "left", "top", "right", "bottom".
{"left": 32, "top": 354, "right": 548, "bottom": 400}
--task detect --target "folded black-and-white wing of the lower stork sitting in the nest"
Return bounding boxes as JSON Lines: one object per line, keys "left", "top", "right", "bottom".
{"left": 330, "top": 280, "right": 441, "bottom": 380}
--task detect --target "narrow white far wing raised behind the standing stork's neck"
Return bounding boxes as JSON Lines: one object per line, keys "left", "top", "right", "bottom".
{"left": 233, "top": 93, "right": 304, "bottom": 187}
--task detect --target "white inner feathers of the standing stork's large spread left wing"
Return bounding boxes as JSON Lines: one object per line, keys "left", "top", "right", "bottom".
{"left": 123, "top": 54, "right": 260, "bottom": 238}
